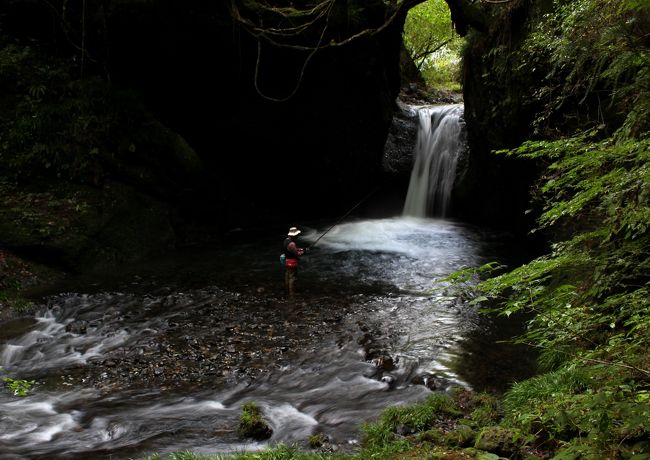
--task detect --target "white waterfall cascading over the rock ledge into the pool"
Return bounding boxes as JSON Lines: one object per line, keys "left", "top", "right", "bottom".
{"left": 403, "top": 104, "right": 464, "bottom": 217}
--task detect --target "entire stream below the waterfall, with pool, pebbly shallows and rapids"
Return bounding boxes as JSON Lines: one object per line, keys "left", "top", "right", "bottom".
{"left": 0, "top": 218, "right": 532, "bottom": 460}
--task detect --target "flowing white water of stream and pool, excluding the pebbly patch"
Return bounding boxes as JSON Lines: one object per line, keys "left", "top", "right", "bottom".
{"left": 0, "top": 218, "right": 532, "bottom": 460}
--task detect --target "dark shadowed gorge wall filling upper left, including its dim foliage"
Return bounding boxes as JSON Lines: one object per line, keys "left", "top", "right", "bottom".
{"left": 2, "top": 1, "right": 403, "bottom": 272}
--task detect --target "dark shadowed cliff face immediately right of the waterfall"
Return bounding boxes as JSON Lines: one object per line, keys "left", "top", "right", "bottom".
{"left": 446, "top": 1, "right": 541, "bottom": 233}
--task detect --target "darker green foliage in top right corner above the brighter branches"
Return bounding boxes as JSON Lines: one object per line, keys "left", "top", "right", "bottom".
{"left": 515, "top": 0, "right": 650, "bottom": 137}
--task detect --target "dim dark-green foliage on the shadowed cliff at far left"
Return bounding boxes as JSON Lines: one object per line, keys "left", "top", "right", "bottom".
{"left": 0, "top": 45, "right": 107, "bottom": 181}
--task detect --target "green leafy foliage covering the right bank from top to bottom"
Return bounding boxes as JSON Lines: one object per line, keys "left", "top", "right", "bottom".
{"left": 442, "top": 0, "right": 650, "bottom": 446}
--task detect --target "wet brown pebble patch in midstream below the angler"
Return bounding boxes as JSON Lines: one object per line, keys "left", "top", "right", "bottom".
{"left": 59, "top": 291, "right": 380, "bottom": 391}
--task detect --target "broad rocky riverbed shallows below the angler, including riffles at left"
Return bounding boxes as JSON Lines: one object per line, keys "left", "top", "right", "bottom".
{"left": 5, "top": 282, "right": 404, "bottom": 393}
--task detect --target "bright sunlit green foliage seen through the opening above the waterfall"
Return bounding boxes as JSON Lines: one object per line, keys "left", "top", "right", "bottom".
{"left": 403, "top": 0, "right": 463, "bottom": 89}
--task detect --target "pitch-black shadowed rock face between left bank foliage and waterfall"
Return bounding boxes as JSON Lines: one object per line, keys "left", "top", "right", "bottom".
{"left": 3, "top": 0, "right": 401, "bottom": 223}
